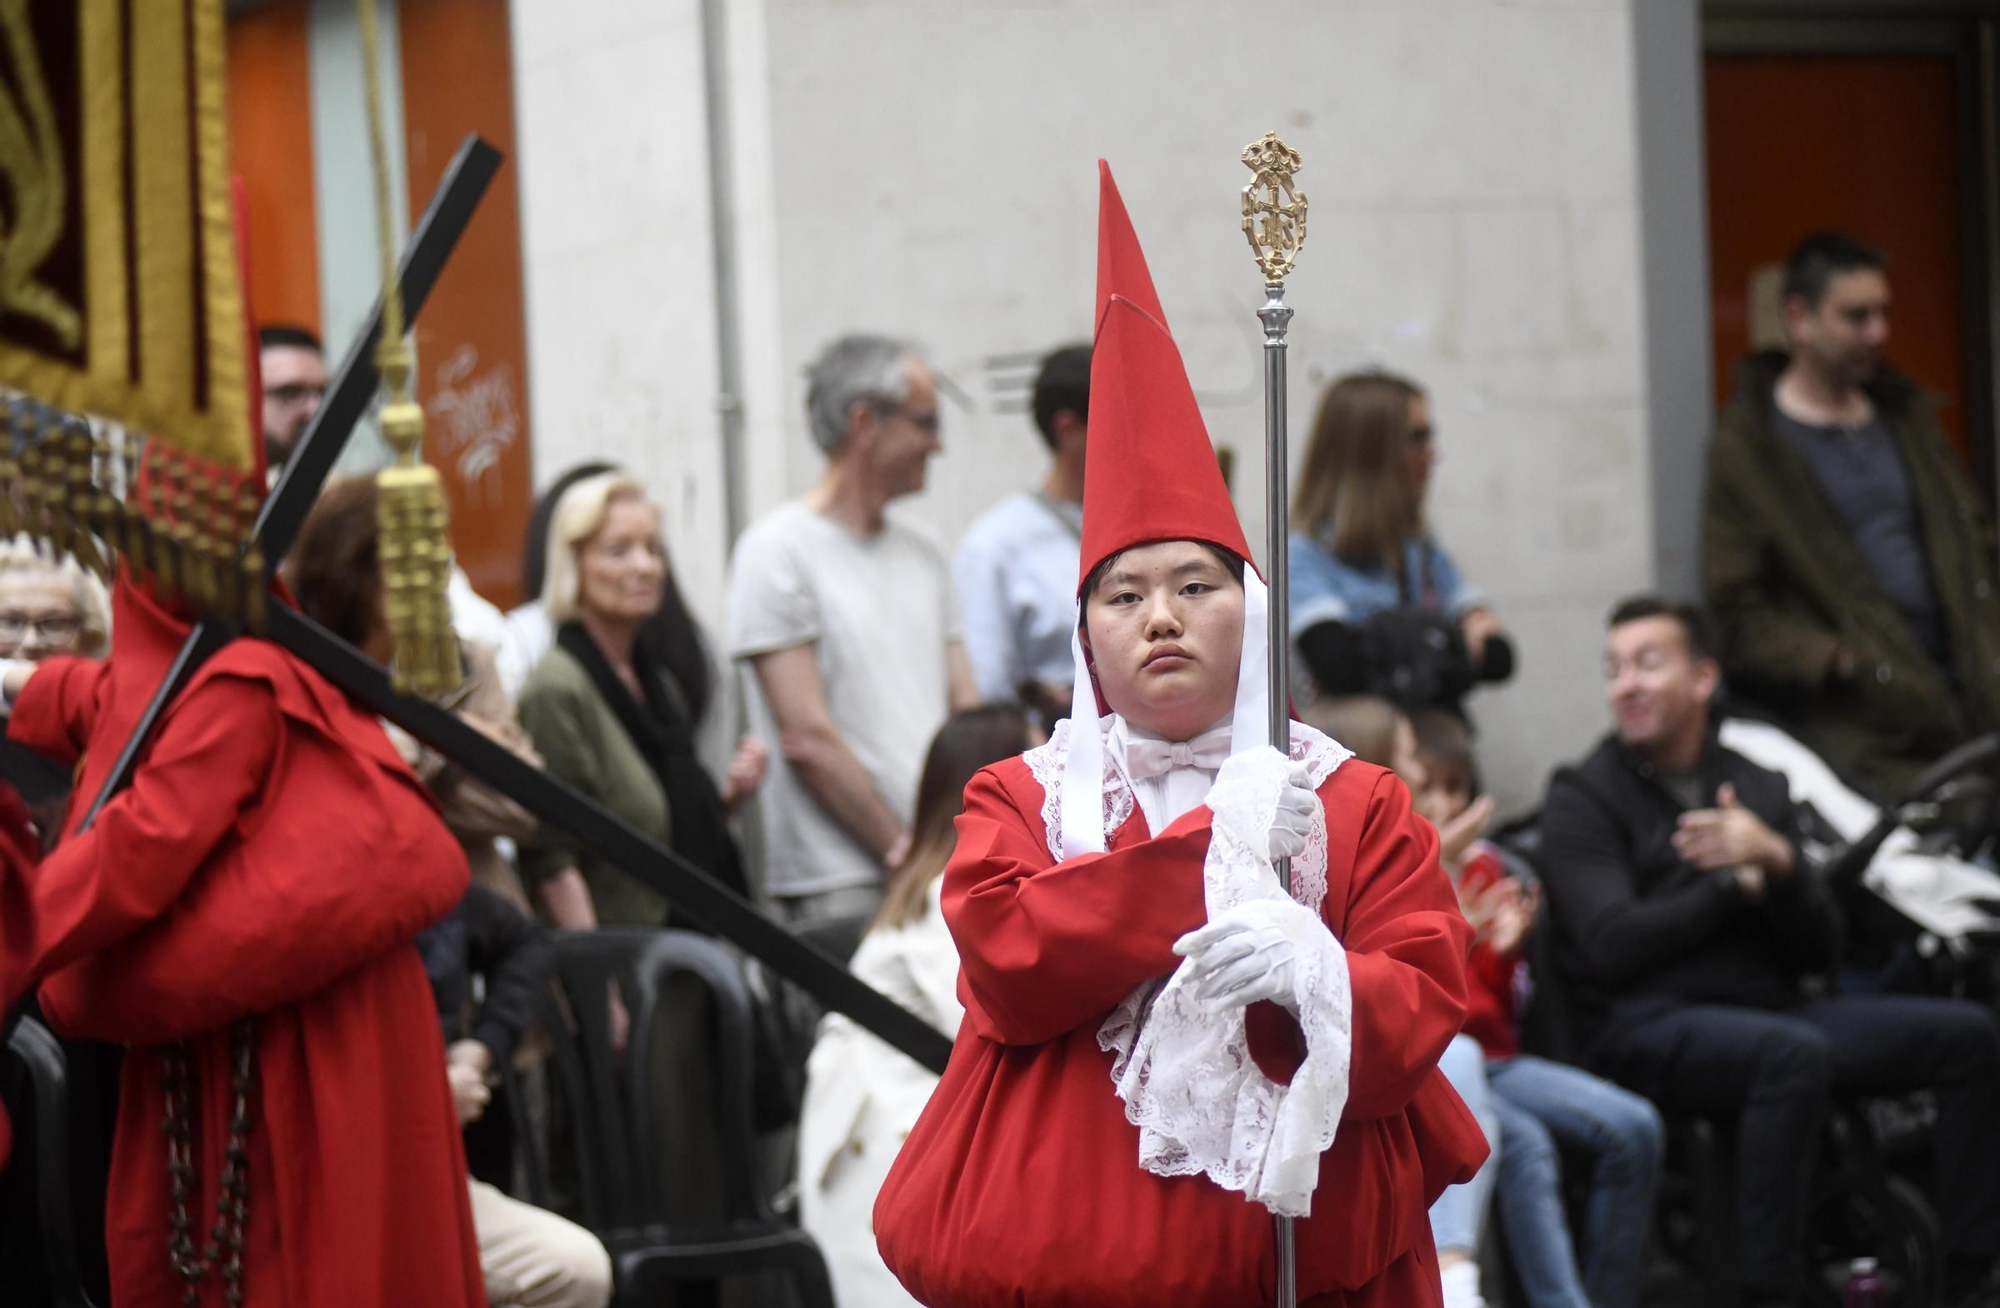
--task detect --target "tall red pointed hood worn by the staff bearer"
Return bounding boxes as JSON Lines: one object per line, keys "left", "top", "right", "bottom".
{"left": 1076, "top": 160, "right": 1250, "bottom": 590}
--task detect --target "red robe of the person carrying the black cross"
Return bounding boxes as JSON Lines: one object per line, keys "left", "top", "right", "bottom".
{"left": 0, "top": 584, "right": 486, "bottom": 1308}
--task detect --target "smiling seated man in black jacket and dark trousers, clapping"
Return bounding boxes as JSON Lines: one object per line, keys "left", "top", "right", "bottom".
{"left": 1542, "top": 598, "right": 2000, "bottom": 1304}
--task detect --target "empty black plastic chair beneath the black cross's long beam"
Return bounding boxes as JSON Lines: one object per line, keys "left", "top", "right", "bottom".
{"left": 548, "top": 928, "right": 834, "bottom": 1308}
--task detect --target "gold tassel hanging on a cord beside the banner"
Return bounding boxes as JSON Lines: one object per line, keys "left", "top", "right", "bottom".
{"left": 360, "top": 0, "right": 462, "bottom": 698}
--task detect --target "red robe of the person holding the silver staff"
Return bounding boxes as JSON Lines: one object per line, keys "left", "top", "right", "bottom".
{"left": 874, "top": 758, "right": 1486, "bottom": 1308}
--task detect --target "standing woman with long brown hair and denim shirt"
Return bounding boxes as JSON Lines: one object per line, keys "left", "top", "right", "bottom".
{"left": 1288, "top": 372, "right": 1514, "bottom": 710}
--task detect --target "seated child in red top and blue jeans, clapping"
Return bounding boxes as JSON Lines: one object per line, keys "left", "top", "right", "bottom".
{"left": 1412, "top": 710, "right": 1664, "bottom": 1308}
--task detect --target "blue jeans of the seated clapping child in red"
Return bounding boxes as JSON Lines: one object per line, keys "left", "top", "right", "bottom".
{"left": 1496, "top": 1054, "right": 1666, "bottom": 1308}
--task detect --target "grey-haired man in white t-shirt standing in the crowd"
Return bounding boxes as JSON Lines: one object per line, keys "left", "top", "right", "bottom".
{"left": 730, "top": 336, "right": 978, "bottom": 924}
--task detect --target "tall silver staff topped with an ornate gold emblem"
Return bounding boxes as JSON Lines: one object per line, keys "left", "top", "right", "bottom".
{"left": 1242, "top": 132, "right": 1306, "bottom": 1308}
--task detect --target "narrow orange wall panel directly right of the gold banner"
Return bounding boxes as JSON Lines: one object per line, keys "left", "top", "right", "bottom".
{"left": 228, "top": 0, "right": 318, "bottom": 338}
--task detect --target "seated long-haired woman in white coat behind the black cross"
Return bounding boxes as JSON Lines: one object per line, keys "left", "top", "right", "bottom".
{"left": 798, "top": 704, "right": 1030, "bottom": 1306}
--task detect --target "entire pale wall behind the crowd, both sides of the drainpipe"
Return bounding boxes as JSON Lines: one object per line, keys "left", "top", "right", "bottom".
{"left": 514, "top": 0, "right": 1654, "bottom": 804}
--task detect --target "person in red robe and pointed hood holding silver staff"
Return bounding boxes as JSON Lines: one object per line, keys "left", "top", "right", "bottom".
{"left": 874, "top": 164, "right": 1486, "bottom": 1308}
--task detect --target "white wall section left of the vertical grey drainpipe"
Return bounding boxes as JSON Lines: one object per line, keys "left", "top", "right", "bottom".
{"left": 512, "top": 0, "right": 726, "bottom": 630}
